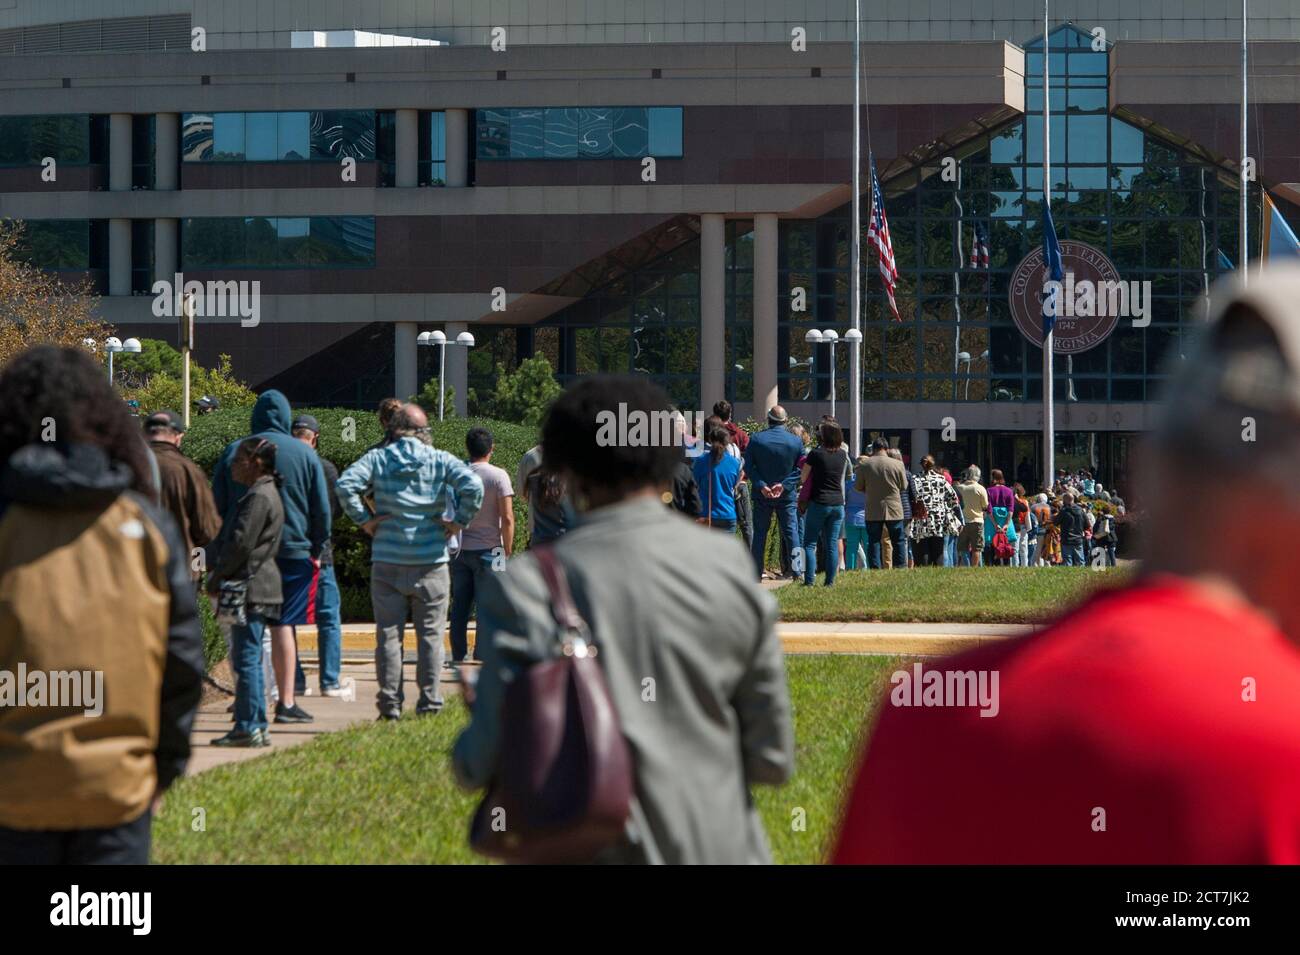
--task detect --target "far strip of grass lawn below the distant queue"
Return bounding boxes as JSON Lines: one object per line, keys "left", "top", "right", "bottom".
{"left": 776, "top": 567, "right": 1130, "bottom": 624}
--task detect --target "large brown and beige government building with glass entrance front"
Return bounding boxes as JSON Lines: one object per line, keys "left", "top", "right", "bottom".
{"left": 0, "top": 0, "right": 1300, "bottom": 490}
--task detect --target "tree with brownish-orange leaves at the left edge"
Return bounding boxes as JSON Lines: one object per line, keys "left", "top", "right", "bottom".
{"left": 0, "top": 220, "right": 113, "bottom": 366}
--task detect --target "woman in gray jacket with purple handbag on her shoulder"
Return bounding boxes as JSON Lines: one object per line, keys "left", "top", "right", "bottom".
{"left": 452, "top": 376, "right": 794, "bottom": 864}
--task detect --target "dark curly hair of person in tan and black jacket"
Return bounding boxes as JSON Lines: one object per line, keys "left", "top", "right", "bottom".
{"left": 0, "top": 344, "right": 155, "bottom": 496}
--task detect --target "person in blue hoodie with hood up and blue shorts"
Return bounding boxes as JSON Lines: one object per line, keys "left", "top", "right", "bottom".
{"left": 212, "top": 388, "right": 330, "bottom": 722}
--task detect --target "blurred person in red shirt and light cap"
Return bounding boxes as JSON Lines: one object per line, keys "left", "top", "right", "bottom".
{"left": 833, "top": 264, "right": 1300, "bottom": 864}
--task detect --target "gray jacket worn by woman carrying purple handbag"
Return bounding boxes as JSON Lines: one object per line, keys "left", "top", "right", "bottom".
{"left": 452, "top": 498, "right": 794, "bottom": 863}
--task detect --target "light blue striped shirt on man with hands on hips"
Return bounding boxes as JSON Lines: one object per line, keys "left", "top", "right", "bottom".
{"left": 337, "top": 437, "right": 484, "bottom": 567}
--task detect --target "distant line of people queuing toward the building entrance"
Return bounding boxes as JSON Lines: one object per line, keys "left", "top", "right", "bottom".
{"left": 671, "top": 401, "right": 1125, "bottom": 586}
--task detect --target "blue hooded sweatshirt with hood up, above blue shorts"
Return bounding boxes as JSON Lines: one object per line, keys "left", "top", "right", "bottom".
{"left": 209, "top": 388, "right": 330, "bottom": 563}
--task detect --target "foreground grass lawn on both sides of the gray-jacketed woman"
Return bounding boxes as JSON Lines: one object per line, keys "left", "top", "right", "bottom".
{"left": 153, "top": 656, "right": 898, "bottom": 863}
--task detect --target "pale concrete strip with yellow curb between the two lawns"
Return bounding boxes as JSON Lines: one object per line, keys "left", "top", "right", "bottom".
{"left": 298, "top": 622, "right": 1040, "bottom": 660}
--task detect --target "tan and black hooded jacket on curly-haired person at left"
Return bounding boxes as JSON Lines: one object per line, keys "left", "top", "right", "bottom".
{"left": 0, "top": 443, "right": 204, "bottom": 829}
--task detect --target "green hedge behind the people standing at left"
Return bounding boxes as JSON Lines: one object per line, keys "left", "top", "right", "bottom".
{"left": 182, "top": 407, "right": 537, "bottom": 631}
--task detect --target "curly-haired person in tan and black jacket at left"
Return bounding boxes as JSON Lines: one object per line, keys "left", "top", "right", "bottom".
{"left": 0, "top": 346, "right": 204, "bottom": 864}
